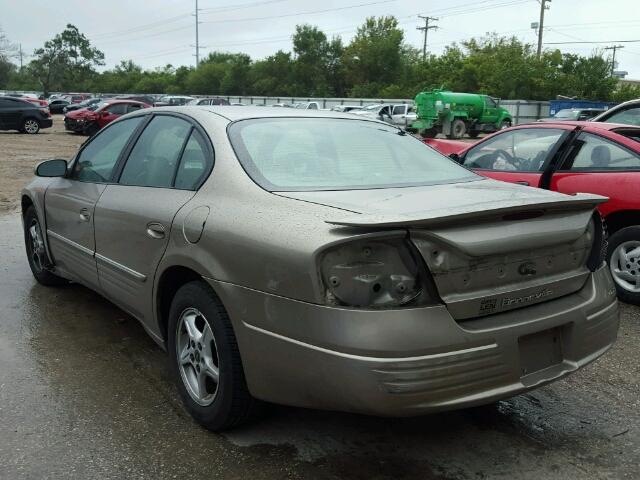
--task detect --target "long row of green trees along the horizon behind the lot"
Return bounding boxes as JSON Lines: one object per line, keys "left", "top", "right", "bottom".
{"left": 0, "top": 16, "right": 640, "bottom": 101}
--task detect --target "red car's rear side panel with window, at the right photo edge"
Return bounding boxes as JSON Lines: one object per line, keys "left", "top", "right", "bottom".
{"left": 550, "top": 132, "right": 640, "bottom": 217}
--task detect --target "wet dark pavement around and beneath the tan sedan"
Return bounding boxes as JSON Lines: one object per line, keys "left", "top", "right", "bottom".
{"left": 0, "top": 214, "right": 640, "bottom": 480}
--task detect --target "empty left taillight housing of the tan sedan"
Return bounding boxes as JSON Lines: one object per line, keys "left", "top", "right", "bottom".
{"left": 320, "top": 238, "right": 436, "bottom": 308}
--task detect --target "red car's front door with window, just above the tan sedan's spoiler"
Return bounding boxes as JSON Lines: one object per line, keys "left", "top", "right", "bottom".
{"left": 460, "top": 127, "right": 571, "bottom": 187}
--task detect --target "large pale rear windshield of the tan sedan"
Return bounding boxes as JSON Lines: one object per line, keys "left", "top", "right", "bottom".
{"left": 229, "top": 118, "right": 480, "bottom": 191}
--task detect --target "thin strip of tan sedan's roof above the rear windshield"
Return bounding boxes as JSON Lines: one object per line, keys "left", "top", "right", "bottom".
{"left": 146, "top": 105, "right": 389, "bottom": 125}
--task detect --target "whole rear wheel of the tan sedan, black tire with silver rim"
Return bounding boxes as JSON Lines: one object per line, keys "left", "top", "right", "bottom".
{"left": 168, "top": 281, "right": 261, "bottom": 432}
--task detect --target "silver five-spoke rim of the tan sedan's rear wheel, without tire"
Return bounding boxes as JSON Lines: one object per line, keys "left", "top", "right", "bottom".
{"left": 175, "top": 308, "right": 220, "bottom": 407}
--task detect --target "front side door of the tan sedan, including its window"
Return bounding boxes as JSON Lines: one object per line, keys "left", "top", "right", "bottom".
{"left": 45, "top": 117, "right": 142, "bottom": 289}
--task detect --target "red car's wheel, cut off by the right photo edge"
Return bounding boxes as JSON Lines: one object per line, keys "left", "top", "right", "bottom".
{"left": 607, "top": 226, "right": 640, "bottom": 305}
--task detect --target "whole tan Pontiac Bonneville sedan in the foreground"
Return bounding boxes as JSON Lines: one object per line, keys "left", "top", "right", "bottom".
{"left": 22, "top": 107, "right": 618, "bottom": 430}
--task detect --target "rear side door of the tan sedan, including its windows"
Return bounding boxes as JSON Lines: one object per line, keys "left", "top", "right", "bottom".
{"left": 95, "top": 114, "right": 213, "bottom": 322}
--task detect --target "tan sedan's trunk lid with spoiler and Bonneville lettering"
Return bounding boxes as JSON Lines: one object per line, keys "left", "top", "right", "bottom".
{"left": 330, "top": 188, "right": 606, "bottom": 320}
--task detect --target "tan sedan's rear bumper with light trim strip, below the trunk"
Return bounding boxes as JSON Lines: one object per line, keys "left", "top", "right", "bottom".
{"left": 209, "top": 268, "right": 618, "bottom": 416}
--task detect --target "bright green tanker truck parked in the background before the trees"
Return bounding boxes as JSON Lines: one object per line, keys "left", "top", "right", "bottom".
{"left": 410, "top": 90, "right": 513, "bottom": 138}
